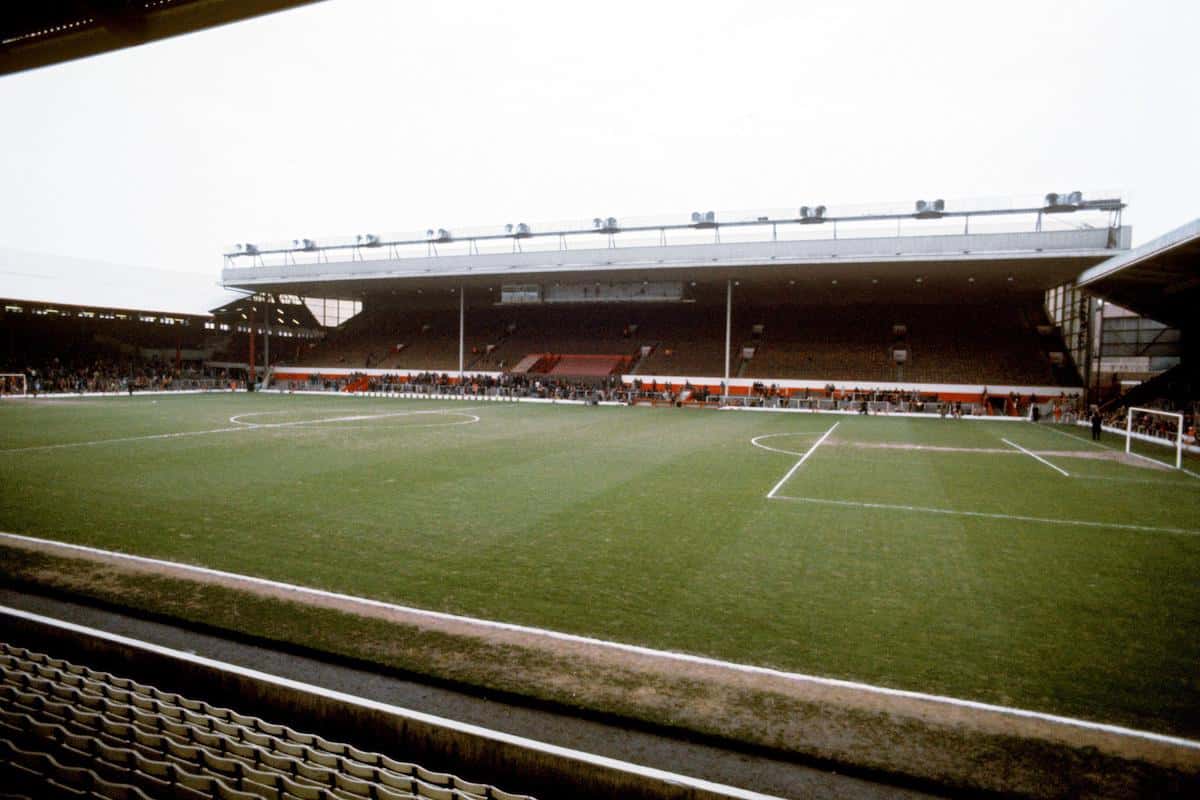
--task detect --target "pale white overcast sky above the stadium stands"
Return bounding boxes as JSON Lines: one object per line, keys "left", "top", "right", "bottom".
{"left": 0, "top": 0, "right": 1200, "bottom": 277}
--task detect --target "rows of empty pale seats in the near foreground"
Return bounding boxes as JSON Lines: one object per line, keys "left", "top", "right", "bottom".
{"left": 0, "top": 643, "right": 535, "bottom": 800}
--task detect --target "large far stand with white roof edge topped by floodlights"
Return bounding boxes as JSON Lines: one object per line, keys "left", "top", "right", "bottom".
{"left": 222, "top": 192, "right": 1152, "bottom": 401}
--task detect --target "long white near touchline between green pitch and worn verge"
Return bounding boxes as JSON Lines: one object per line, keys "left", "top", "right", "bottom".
{"left": 0, "top": 532, "right": 1200, "bottom": 750}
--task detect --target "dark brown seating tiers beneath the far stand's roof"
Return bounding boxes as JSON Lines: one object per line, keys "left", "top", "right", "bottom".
{"left": 274, "top": 297, "right": 1078, "bottom": 386}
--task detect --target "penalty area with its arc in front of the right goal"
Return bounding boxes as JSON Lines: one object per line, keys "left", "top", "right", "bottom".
{"left": 755, "top": 420, "right": 1200, "bottom": 534}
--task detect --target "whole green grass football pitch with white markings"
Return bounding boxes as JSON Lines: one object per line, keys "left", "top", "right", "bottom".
{"left": 0, "top": 395, "right": 1200, "bottom": 736}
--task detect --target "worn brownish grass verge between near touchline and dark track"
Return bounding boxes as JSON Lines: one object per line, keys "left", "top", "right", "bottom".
{"left": 0, "top": 547, "right": 1200, "bottom": 796}
